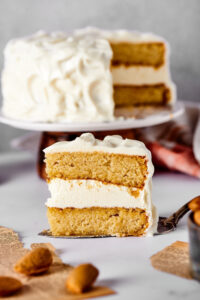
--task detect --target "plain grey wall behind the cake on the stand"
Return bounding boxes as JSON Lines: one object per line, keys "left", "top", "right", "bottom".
{"left": 0, "top": 0, "right": 200, "bottom": 151}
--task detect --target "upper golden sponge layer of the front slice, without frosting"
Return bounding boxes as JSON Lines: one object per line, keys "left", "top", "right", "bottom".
{"left": 46, "top": 152, "right": 148, "bottom": 188}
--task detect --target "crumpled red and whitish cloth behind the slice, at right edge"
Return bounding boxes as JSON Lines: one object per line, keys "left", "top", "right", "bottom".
{"left": 136, "top": 106, "right": 200, "bottom": 178}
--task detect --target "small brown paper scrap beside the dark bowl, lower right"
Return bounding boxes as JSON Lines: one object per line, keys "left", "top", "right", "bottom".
{"left": 150, "top": 241, "right": 192, "bottom": 279}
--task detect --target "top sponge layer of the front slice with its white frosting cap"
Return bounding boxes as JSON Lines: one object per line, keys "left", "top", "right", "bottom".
{"left": 44, "top": 133, "right": 154, "bottom": 188}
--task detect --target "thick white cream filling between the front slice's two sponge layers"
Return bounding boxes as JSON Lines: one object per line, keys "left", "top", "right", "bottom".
{"left": 46, "top": 178, "right": 157, "bottom": 235}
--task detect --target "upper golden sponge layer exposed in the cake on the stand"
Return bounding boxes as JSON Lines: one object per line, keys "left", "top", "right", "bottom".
{"left": 111, "top": 42, "right": 165, "bottom": 68}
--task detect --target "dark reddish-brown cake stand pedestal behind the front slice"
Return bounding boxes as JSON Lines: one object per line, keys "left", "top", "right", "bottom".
{"left": 37, "top": 129, "right": 135, "bottom": 179}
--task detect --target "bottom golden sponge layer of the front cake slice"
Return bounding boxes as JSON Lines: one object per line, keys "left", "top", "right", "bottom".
{"left": 47, "top": 207, "right": 148, "bottom": 236}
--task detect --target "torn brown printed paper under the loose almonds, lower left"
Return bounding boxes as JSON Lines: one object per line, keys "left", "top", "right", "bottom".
{"left": 0, "top": 227, "right": 115, "bottom": 300}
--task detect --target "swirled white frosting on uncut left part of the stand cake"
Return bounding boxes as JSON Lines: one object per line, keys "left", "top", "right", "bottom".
{"left": 2, "top": 32, "right": 114, "bottom": 122}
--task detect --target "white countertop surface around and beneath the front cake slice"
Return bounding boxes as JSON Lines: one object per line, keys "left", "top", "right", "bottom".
{"left": 0, "top": 152, "right": 200, "bottom": 300}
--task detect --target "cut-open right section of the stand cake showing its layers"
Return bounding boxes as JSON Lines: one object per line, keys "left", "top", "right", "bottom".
{"left": 75, "top": 27, "right": 176, "bottom": 106}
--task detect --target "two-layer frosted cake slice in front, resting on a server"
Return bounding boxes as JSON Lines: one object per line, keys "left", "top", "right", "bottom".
{"left": 44, "top": 133, "right": 157, "bottom": 236}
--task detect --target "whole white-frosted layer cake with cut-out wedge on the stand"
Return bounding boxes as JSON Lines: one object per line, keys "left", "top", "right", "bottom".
{"left": 2, "top": 29, "right": 176, "bottom": 122}
